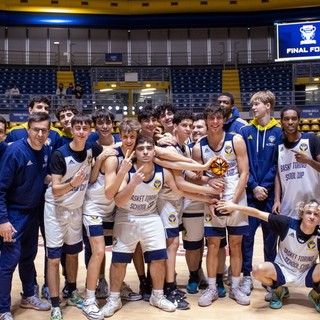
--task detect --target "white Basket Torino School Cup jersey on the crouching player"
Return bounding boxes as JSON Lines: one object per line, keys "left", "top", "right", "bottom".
{"left": 275, "top": 219, "right": 319, "bottom": 275}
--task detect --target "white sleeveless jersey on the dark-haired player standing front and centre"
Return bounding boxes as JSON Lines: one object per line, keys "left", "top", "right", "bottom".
{"left": 116, "top": 164, "right": 164, "bottom": 216}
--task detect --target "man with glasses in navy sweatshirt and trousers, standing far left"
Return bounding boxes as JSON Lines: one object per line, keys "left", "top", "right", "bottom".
{"left": 0, "top": 112, "right": 50, "bottom": 320}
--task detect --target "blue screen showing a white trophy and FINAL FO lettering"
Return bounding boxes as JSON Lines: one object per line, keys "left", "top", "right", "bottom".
{"left": 275, "top": 21, "right": 320, "bottom": 61}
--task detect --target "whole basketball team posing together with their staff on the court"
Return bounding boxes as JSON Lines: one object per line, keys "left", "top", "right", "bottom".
{"left": 0, "top": 91, "right": 320, "bottom": 320}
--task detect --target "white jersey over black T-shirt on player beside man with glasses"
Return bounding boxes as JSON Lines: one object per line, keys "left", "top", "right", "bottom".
{"left": 45, "top": 144, "right": 92, "bottom": 210}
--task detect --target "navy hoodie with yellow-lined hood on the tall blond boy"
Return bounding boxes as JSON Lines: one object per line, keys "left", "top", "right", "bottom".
{"left": 240, "top": 118, "right": 282, "bottom": 199}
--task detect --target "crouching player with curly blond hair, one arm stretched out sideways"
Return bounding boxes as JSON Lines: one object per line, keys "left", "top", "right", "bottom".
{"left": 217, "top": 200, "right": 320, "bottom": 312}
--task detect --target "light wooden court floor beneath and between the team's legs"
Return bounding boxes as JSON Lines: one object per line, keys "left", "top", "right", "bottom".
{"left": 8, "top": 230, "right": 320, "bottom": 320}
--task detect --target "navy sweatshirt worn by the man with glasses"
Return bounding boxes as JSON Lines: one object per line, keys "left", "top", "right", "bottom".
{"left": 0, "top": 139, "right": 51, "bottom": 223}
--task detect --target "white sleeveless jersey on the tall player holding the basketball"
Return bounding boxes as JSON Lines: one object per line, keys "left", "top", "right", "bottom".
{"left": 200, "top": 133, "right": 239, "bottom": 199}
